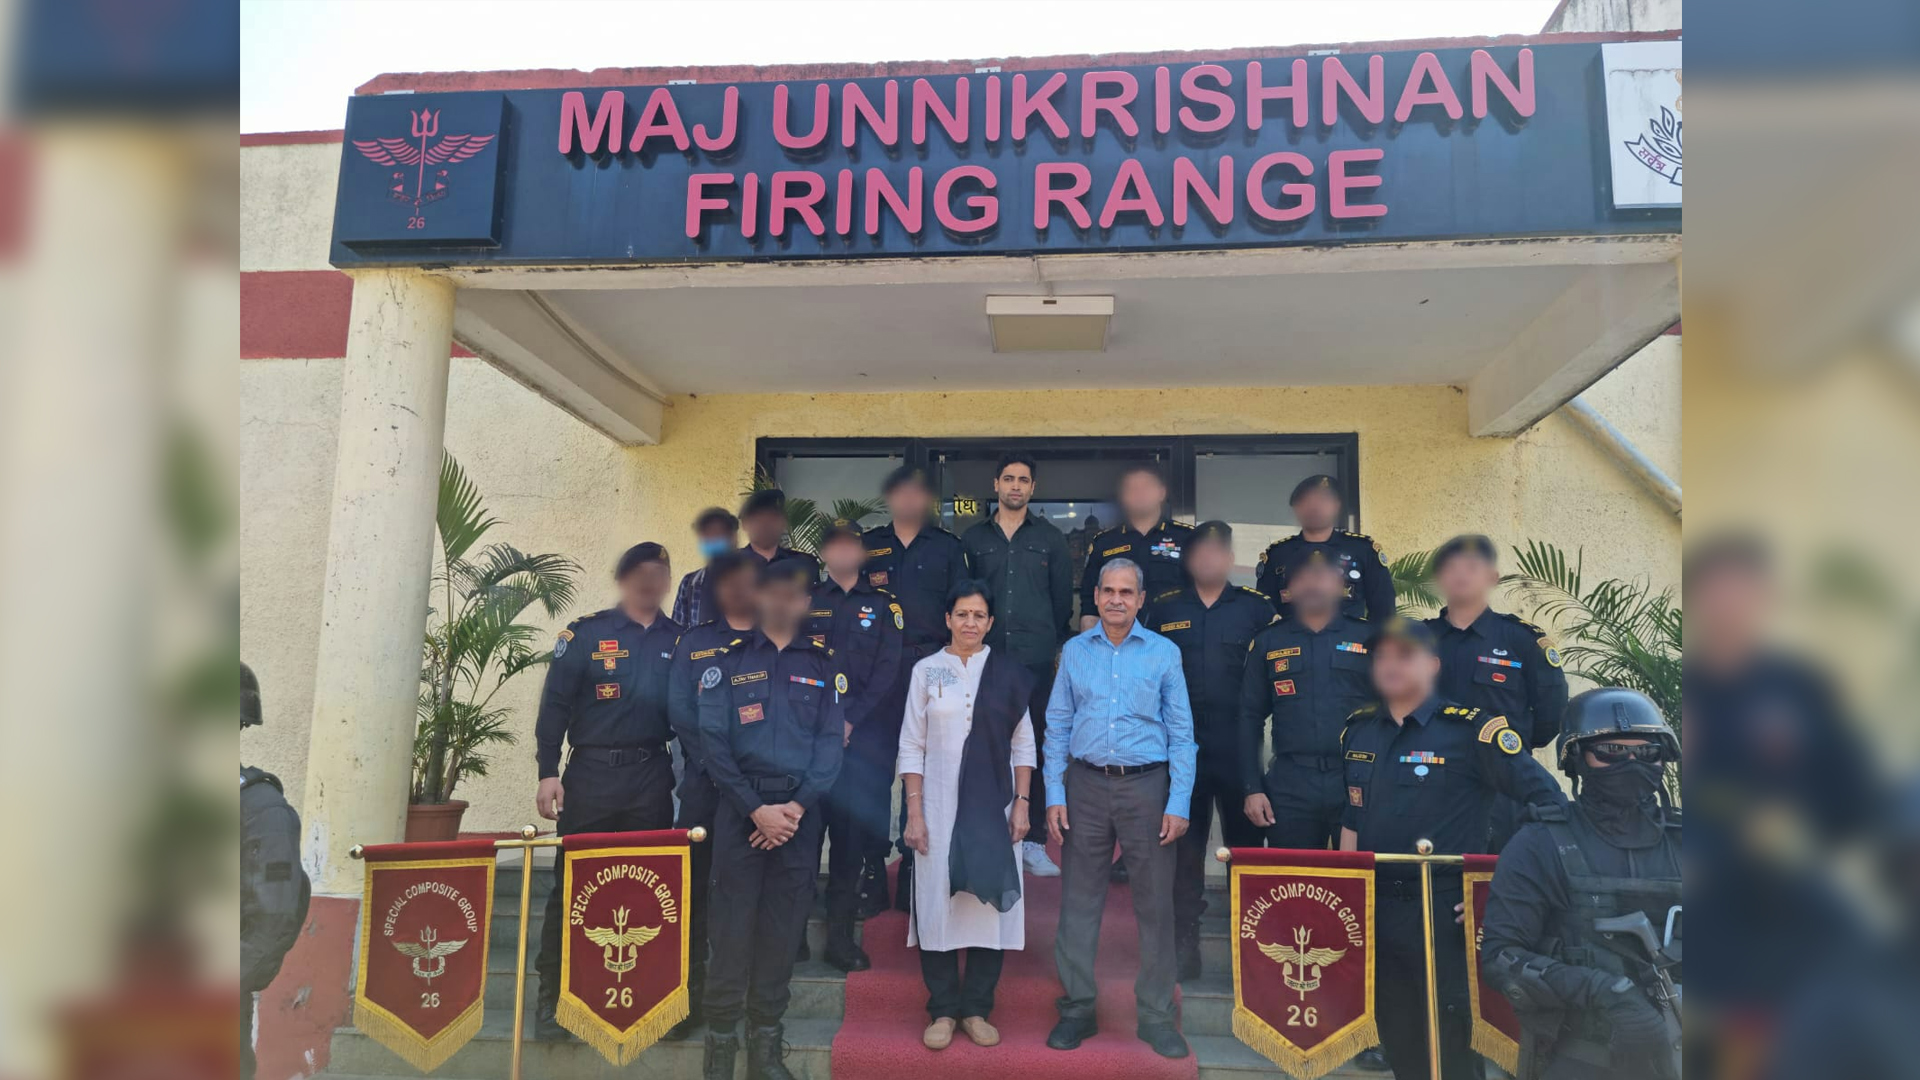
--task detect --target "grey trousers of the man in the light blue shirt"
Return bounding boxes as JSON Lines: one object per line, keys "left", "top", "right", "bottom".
{"left": 1054, "top": 761, "right": 1177, "bottom": 1024}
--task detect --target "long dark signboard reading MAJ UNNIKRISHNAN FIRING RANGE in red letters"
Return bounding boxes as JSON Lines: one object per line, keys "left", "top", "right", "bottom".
{"left": 332, "top": 44, "right": 1680, "bottom": 265}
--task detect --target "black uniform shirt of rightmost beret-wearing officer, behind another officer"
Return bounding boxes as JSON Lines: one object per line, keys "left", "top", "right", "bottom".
{"left": 1427, "top": 609, "right": 1567, "bottom": 748}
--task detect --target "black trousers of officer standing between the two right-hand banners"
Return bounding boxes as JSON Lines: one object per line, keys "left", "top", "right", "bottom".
{"left": 1375, "top": 872, "right": 1486, "bottom": 1080}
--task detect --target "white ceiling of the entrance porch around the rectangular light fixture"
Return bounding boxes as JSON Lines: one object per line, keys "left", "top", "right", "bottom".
{"left": 540, "top": 265, "right": 1586, "bottom": 394}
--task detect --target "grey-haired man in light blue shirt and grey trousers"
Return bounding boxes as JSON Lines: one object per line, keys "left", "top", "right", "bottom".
{"left": 1044, "top": 559, "right": 1196, "bottom": 1057}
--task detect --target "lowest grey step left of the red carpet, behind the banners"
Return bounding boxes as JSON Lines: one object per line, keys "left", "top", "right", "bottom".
{"left": 326, "top": 1017, "right": 839, "bottom": 1080}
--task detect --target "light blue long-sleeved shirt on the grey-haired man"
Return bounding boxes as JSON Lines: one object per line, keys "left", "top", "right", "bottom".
{"left": 1044, "top": 621, "right": 1196, "bottom": 817}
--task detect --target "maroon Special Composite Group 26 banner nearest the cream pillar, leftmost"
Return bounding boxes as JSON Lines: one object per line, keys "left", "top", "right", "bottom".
{"left": 353, "top": 840, "right": 493, "bottom": 1072}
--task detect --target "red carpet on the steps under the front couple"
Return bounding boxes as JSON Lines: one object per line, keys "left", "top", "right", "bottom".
{"left": 833, "top": 851, "right": 1198, "bottom": 1080}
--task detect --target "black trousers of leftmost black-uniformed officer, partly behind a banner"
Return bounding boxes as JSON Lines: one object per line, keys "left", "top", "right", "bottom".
{"left": 534, "top": 749, "right": 679, "bottom": 1007}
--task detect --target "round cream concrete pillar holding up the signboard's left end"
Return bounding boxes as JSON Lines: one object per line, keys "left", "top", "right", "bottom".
{"left": 301, "top": 269, "right": 455, "bottom": 896}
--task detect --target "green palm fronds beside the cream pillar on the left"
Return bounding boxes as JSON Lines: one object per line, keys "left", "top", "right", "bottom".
{"left": 411, "top": 454, "right": 580, "bottom": 803}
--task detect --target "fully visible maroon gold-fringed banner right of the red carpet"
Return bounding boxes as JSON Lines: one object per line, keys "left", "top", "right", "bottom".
{"left": 1231, "top": 847, "right": 1380, "bottom": 1080}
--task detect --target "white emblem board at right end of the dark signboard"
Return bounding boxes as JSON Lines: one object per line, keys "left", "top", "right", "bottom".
{"left": 1599, "top": 40, "right": 1680, "bottom": 209}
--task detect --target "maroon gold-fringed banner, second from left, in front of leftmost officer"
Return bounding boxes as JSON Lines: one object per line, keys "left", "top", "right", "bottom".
{"left": 557, "top": 828, "right": 693, "bottom": 1065}
